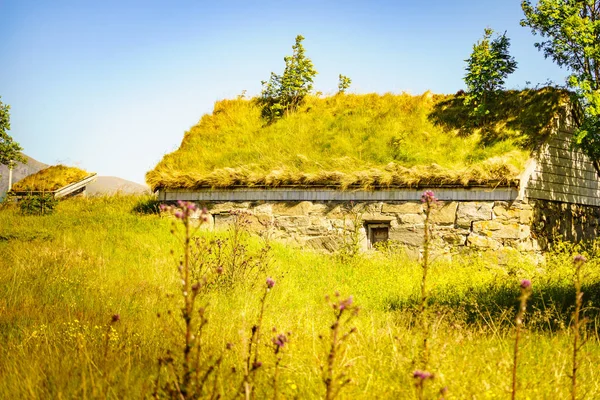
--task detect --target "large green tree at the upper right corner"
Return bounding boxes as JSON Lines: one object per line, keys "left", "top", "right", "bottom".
{"left": 521, "top": 0, "right": 600, "bottom": 161}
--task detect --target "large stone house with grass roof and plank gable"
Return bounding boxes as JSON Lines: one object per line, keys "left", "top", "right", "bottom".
{"left": 147, "top": 88, "right": 600, "bottom": 253}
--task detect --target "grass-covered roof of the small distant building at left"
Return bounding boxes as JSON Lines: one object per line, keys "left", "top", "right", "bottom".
{"left": 12, "top": 165, "right": 92, "bottom": 192}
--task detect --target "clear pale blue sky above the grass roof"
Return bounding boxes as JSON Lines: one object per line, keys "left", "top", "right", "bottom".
{"left": 0, "top": 0, "right": 568, "bottom": 183}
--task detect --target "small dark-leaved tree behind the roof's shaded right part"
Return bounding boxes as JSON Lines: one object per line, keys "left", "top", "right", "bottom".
{"left": 465, "top": 28, "right": 517, "bottom": 121}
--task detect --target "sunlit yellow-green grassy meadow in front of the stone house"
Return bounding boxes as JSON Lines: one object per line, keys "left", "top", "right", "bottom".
{"left": 0, "top": 195, "right": 600, "bottom": 399}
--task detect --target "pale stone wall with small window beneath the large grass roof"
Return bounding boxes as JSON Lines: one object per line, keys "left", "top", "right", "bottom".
{"left": 195, "top": 201, "right": 540, "bottom": 253}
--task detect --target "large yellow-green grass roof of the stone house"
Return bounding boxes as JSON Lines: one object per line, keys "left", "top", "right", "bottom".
{"left": 146, "top": 88, "right": 569, "bottom": 190}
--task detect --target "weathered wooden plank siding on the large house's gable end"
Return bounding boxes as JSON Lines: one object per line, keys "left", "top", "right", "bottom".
{"left": 525, "top": 130, "right": 600, "bottom": 206}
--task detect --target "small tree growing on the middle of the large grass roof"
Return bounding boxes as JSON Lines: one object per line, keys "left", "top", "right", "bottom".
{"left": 260, "top": 35, "right": 317, "bottom": 122}
